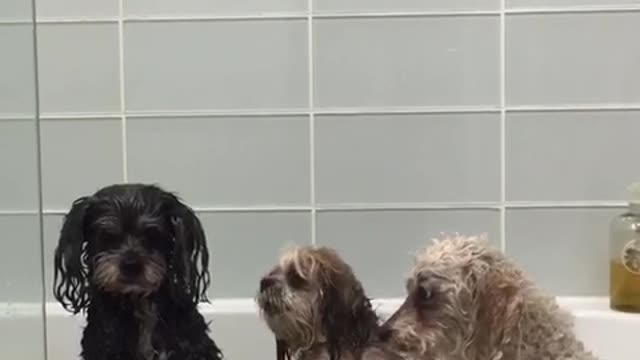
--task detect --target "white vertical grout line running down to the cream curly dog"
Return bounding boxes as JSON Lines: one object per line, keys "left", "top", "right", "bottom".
{"left": 499, "top": 0, "right": 507, "bottom": 253}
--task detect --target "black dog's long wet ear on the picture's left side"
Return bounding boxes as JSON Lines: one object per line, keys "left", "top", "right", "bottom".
{"left": 53, "top": 197, "right": 89, "bottom": 314}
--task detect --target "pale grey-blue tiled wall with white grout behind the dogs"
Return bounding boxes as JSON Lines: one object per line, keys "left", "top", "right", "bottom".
{"left": 0, "top": 0, "right": 640, "bottom": 358}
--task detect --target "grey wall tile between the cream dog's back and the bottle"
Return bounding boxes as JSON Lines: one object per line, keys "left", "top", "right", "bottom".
{"left": 506, "top": 209, "right": 623, "bottom": 296}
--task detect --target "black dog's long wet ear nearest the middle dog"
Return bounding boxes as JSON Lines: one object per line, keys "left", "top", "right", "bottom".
{"left": 165, "top": 195, "right": 210, "bottom": 303}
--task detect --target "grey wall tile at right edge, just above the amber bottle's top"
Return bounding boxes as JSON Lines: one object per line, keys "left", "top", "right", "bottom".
{"left": 506, "top": 111, "right": 640, "bottom": 201}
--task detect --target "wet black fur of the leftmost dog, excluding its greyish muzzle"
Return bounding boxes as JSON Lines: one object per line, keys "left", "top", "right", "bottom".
{"left": 54, "top": 184, "right": 222, "bottom": 360}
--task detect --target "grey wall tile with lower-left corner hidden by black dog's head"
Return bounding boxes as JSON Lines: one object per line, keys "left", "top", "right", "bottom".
{"left": 127, "top": 117, "right": 310, "bottom": 207}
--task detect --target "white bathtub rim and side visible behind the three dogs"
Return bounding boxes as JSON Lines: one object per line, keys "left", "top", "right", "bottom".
{"left": 0, "top": 298, "right": 640, "bottom": 360}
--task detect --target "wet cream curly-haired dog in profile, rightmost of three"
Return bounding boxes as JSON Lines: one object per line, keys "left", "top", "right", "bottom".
{"left": 385, "top": 236, "right": 596, "bottom": 360}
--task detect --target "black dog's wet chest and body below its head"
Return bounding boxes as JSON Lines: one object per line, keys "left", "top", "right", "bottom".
{"left": 81, "top": 293, "right": 222, "bottom": 360}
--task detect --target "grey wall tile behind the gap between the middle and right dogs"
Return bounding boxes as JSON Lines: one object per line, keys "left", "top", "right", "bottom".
{"left": 317, "top": 210, "right": 500, "bottom": 298}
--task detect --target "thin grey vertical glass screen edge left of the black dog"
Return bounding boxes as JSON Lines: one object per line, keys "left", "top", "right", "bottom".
{"left": 30, "top": 0, "right": 49, "bottom": 360}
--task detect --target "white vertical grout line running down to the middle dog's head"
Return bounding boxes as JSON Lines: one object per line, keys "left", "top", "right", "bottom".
{"left": 307, "top": 0, "right": 318, "bottom": 245}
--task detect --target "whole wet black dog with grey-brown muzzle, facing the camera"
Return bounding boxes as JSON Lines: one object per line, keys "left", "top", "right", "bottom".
{"left": 54, "top": 184, "right": 222, "bottom": 360}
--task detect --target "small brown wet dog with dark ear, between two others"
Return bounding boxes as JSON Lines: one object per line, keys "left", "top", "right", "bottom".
{"left": 256, "top": 246, "right": 397, "bottom": 360}
